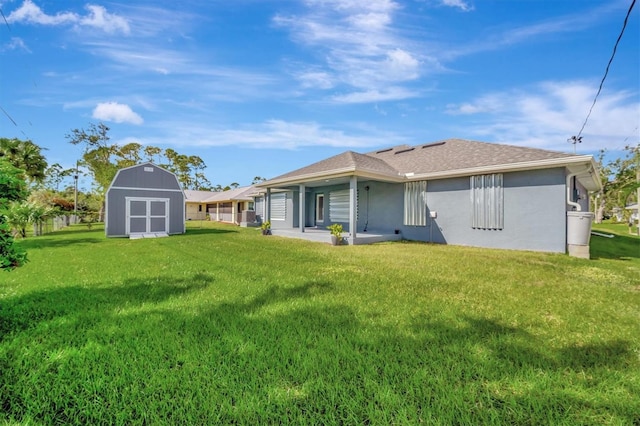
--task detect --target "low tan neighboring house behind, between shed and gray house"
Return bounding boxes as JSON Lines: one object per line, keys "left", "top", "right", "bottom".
{"left": 184, "top": 185, "right": 256, "bottom": 225}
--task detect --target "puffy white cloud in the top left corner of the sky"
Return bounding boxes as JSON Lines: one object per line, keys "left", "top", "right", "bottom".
{"left": 7, "top": 0, "right": 129, "bottom": 34}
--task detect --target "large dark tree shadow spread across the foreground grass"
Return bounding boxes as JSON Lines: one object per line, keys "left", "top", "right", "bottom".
{"left": 0, "top": 273, "right": 640, "bottom": 424}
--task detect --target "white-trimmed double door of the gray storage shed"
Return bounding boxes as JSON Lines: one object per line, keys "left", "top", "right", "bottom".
{"left": 126, "top": 197, "right": 169, "bottom": 235}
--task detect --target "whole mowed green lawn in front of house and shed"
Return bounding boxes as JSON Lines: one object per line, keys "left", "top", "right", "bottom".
{"left": 0, "top": 222, "right": 640, "bottom": 425}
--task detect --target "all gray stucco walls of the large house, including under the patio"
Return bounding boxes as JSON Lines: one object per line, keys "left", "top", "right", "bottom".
{"left": 272, "top": 168, "right": 566, "bottom": 253}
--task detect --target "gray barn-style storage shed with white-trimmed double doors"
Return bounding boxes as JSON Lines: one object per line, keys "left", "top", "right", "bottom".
{"left": 105, "top": 163, "right": 185, "bottom": 237}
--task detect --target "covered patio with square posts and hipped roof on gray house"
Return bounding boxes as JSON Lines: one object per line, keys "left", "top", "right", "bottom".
{"left": 258, "top": 151, "right": 405, "bottom": 248}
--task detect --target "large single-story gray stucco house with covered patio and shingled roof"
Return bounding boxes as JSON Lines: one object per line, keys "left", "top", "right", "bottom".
{"left": 256, "top": 139, "right": 600, "bottom": 257}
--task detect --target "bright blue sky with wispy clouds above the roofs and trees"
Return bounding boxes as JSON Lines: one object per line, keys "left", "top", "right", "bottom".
{"left": 0, "top": 0, "right": 640, "bottom": 190}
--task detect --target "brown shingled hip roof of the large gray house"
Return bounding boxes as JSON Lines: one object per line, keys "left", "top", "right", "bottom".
{"left": 259, "top": 139, "right": 600, "bottom": 190}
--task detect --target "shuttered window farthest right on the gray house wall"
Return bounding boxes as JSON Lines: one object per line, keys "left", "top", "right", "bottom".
{"left": 471, "top": 173, "right": 504, "bottom": 230}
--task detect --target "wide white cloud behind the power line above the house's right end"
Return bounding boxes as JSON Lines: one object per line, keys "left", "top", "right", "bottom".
{"left": 447, "top": 81, "right": 640, "bottom": 151}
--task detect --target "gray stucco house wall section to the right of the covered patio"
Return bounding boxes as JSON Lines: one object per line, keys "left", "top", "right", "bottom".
{"left": 412, "top": 169, "right": 566, "bottom": 253}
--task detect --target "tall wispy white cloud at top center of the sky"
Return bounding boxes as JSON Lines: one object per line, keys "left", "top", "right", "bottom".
{"left": 274, "top": 0, "right": 423, "bottom": 102}
